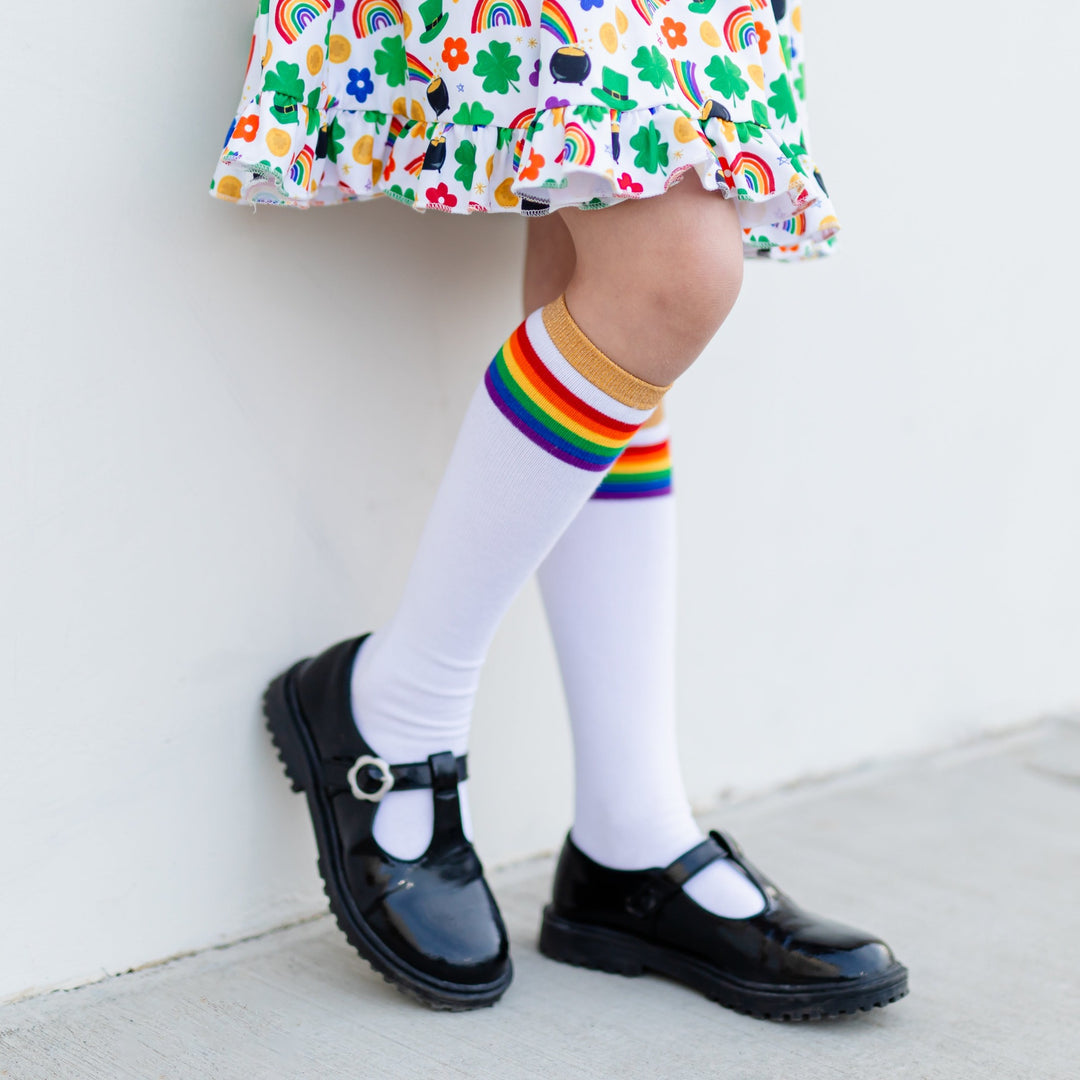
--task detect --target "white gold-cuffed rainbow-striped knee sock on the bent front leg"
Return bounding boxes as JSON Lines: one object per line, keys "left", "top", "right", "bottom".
{"left": 352, "top": 297, "right": 666, "bottom": 859}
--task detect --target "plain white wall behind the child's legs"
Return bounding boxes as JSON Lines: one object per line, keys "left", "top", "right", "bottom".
{"left": 0, "top": 0, "right": 1080, "bottom": 997}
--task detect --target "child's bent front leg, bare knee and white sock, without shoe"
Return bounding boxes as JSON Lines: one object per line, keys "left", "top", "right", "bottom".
{"left": 353, "top": 176, "right": 742, "bottom": 856}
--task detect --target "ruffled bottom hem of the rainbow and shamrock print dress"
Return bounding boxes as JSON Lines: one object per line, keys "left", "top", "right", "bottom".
{"left": 211, "top": 95, "right": 839, "bottom": 260}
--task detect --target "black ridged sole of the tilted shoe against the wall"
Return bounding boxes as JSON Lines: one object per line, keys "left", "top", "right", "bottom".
{"left": 262, "top": 660, "right": 513, "bottom": 1012}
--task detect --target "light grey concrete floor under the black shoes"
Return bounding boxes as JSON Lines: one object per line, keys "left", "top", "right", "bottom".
{"left": 0, "top": 723, "right": 1080, "bottom": 1080}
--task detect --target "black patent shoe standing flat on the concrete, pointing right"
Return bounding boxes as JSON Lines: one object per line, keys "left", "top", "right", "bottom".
{"left": 540, "top": 831, "right": 907, "bottom": 1020}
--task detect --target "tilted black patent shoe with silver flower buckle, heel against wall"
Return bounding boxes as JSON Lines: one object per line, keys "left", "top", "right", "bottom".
{"left": 264, "top": 635, "right": 512, "bottom": 1010}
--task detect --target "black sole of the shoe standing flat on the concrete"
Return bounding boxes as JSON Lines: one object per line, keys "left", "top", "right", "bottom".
{"left": 540, "top": 905, "right": 907, "bottom": 1021}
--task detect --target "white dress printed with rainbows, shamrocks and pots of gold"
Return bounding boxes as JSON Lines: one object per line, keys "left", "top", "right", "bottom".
{"left": 212, "top": 0, "right": 837, "bottom": 259}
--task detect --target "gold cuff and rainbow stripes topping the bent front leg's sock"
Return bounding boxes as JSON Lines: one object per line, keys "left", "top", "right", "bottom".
{"left": 484, "top": 296, "right": 667, "bottom": 472}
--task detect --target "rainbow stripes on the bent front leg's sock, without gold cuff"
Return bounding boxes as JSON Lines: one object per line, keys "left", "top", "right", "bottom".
{"left": 484, "top": 322, "right": 638, "bottom": 472}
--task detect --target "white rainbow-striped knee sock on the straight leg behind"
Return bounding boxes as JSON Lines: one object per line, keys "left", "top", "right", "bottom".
{"left": 539, "top": 419, "right": 764, "bottom": 918}
